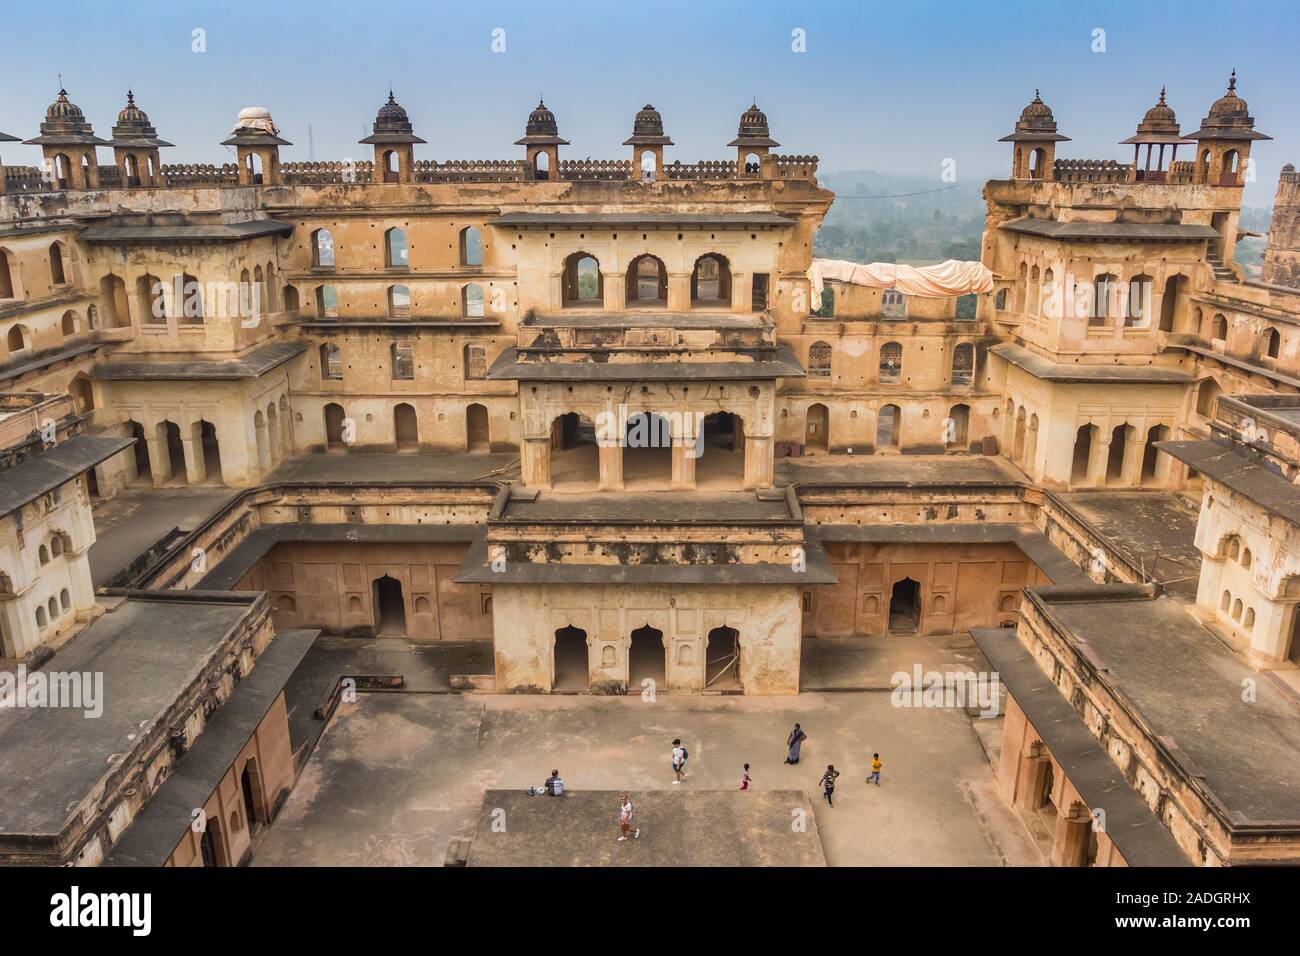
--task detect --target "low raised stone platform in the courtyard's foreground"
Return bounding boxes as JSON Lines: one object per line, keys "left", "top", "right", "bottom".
{"left": 468, "top": 782, "right": 826, "bottom": 866}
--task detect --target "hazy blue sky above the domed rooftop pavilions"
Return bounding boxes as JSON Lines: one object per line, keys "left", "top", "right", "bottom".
{"left": 0, "top": 0, "right": 1300, "bottom": 206}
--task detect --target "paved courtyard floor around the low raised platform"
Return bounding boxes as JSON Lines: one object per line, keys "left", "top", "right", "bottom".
{"left": 255, "top": 692, "right": 1035, "bottom": 866}
